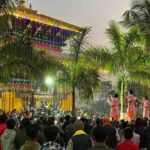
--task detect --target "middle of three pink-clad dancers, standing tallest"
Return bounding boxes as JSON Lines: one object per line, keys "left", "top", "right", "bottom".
{"left": 126, "top": 90, "right": 136, "bottom": 121}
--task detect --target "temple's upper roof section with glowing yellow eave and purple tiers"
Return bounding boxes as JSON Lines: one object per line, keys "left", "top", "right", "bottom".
{"left": 11, "top": 0, "right": 83, "bottom": 58}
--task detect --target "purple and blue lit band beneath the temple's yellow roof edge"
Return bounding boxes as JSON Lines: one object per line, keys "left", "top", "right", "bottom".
{"left": 12, "top": 17, "right": 76, "bottom": 49}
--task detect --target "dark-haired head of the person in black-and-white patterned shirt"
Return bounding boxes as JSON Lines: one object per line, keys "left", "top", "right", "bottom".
{"left": 44, "top": 125, "right": 59, "bottom": 142}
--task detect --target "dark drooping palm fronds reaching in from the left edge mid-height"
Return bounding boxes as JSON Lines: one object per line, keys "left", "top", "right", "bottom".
{"left": 0, "top": 31, "right": 62, "bottom": 81}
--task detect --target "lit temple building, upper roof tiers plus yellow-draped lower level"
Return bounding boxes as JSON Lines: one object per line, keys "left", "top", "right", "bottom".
{"left": 0, "top": 0, "right": 83, "bottom": 111}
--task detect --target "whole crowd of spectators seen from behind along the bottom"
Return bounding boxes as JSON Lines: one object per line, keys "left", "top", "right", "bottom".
{"left": 0, "top": 108, "right": 150, "bottom": 150}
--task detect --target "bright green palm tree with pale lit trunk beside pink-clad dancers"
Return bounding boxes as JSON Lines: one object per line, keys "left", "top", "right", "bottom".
{"left": 86, "top": 22, "right": 150, "bottom": 117}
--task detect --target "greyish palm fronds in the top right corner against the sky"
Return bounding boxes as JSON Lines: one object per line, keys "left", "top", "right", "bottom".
{"left": 121, "top": 0, "right": 150, "bottom": 50}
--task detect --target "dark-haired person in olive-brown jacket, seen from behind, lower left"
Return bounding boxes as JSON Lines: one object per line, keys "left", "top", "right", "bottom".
{"left": 19, "top": 124, "right": 40, "bottom": 150}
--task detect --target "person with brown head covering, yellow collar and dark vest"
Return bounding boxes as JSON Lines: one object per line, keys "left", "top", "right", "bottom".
{"left": 67, "top": 120, "right": 92, "bottom": 150}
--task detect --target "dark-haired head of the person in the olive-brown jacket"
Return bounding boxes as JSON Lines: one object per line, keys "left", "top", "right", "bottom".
{"left": 26, "top": 124, "right": 40, "bottom": 141}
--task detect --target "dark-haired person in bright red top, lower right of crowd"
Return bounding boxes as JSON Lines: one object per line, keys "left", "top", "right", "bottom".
{"left": 117, "top": 127, "right": 139, "bottom": 150}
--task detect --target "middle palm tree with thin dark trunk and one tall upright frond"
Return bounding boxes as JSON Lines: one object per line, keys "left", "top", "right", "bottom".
{"left": 59, "top": 28, "right": 100, "bottom": 115}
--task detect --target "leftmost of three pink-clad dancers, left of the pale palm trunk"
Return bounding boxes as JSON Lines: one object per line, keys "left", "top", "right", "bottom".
{"left": 109, "top": 93, "right": 119, "bottom": 121}
